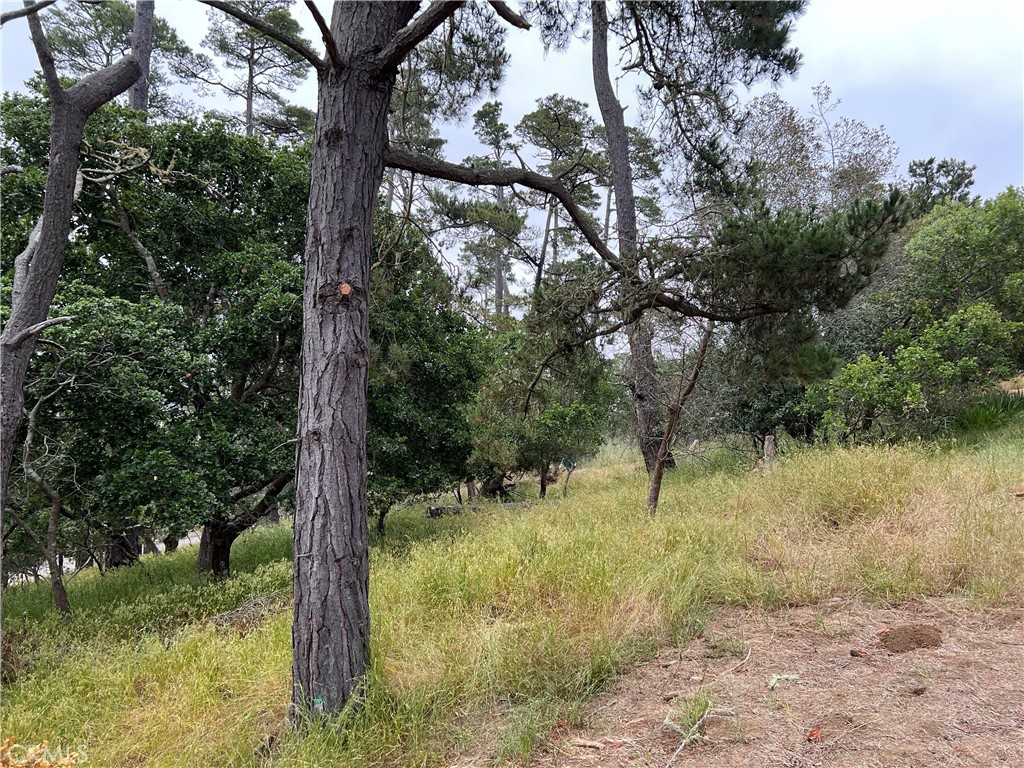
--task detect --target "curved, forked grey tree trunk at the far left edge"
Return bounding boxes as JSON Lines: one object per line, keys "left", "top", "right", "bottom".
{"left": 0, "top": 7, "right": 140, "bottom": 593}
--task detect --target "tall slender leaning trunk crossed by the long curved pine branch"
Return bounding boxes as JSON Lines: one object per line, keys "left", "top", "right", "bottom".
{"left": 591, "top": 2, "right": 674, "bottom": 473}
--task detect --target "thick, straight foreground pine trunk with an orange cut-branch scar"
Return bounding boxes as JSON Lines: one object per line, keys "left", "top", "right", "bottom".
{"left": 292, "top": 3, "right": 417, "bottom": 716}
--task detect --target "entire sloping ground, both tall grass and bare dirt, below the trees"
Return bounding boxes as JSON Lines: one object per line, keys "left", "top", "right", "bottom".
{"left": 0, "top": 422, "right": 1024, "bottom": 768}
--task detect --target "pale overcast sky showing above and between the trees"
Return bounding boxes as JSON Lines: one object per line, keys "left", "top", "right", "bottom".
{"left": 6, "top": 0, "right": 1024, "bottom": 197}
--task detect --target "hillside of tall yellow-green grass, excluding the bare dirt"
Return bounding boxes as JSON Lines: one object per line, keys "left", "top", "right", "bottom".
{"left": 2, "top": 421, "right": 1024, "bottom": 766}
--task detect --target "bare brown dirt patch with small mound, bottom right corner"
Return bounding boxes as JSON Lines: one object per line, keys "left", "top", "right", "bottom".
{"left": 531, "top": 598, "right": 1024, "bottom": 768}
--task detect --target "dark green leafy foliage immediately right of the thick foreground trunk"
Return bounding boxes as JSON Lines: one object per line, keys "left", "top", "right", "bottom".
{"left": 368, "top": 210, "right": 485, "bottom": 513}
